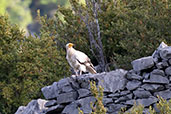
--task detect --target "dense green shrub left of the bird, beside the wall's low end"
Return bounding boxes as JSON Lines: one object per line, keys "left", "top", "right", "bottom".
{"left": 0, "top": 16, "right": 69, "bottom": 114}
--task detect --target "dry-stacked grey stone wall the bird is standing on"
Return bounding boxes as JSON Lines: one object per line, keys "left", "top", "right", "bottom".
{"left": 16, "top": 43, "right": 171, "bottom": 114}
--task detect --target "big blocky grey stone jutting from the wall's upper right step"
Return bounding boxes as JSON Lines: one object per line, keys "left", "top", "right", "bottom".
{"left": 131, "top": 56, "right": 154, "bottom": 71}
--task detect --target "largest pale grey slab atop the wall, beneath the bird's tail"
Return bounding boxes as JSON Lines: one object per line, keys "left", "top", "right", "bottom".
{"left": 72, "top": 69, "right": 127, "bottom": 93}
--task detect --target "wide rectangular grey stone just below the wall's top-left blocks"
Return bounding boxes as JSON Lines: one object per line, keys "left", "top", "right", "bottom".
{"left": 57, "top": 92, "right": 78, "bottom": 104}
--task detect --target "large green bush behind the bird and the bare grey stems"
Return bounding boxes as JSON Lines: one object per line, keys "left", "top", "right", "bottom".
{"left": 38, "top": 0, "right": 171, "bottom": 69}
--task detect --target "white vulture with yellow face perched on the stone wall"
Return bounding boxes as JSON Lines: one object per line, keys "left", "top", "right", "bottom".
{"left": 66, "top": 43, "right": 97, "bottom": 76}
